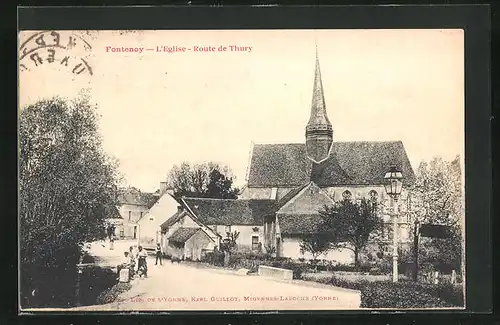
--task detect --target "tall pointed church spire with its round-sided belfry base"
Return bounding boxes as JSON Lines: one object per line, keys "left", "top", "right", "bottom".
{"left": 306, "top": 47, "right": 333, "bottom": 163}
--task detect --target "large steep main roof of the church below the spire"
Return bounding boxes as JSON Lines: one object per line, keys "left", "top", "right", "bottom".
{"left": 248, "top": 141, "right": 415, "bottom": 187}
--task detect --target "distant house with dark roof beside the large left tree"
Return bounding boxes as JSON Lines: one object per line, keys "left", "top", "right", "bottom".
{"left": 115, "top": 187, "right": 156, "bottom": 239}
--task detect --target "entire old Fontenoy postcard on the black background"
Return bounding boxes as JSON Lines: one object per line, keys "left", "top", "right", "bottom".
{"left": 19, "top": 29, "right": 465, "bottom": 312}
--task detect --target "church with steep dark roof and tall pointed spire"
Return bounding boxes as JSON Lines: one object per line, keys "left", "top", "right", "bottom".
{"left": 236, "top": 51, "right": 415, "bottom": 260}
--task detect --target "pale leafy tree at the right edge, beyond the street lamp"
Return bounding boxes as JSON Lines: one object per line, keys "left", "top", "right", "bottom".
{"left": 411, "top": 156, "right": 464, "bottom": 269}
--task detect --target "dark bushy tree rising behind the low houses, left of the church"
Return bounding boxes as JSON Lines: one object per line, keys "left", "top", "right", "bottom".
{"left": 167, "top": 162, "right": 238, "bottom": 199}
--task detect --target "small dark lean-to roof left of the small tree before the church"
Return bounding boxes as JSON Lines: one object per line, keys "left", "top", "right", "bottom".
{"left": 278, "top": 213, "right": 323, "bottom": 236}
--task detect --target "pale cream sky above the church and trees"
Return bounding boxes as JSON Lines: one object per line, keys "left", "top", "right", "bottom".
{"left": 19, "top": 30, "right": 464, "bottom": 191}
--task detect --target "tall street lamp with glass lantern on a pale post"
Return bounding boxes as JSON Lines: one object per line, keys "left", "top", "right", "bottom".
{"left": 384, "top": 166, "right": 403, "bottom": 282}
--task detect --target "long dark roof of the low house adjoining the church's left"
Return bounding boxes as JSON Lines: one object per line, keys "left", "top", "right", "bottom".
{"left": 183, "top": 198, "right": 275, "bottom": 225}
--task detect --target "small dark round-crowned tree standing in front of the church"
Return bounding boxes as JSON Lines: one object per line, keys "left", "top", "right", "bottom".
{"left": 320, "top": 199, "right": 382, "bottom": 267}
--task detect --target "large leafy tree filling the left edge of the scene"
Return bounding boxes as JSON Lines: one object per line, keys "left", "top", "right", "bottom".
{"left": 19, "top": 97, "right": 118, "bottom": 266}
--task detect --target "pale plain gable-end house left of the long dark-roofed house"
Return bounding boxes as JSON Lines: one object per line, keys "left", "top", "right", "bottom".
{"left": 137, "top": 182, "right": 179, "bottom": 250}
